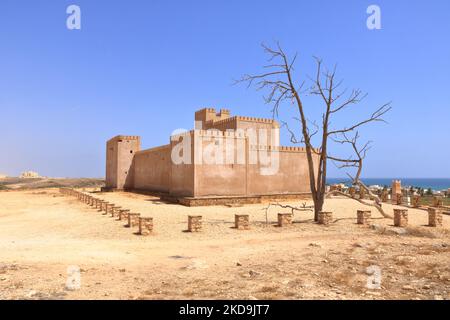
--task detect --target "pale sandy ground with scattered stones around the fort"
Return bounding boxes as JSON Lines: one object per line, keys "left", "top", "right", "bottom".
{"left": 0, "top": 189, "right": 450, "bottom": 299}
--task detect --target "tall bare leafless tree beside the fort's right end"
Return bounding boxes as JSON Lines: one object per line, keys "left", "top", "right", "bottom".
{"left": 236, "top": 43, "right": 391, "bottom": 221}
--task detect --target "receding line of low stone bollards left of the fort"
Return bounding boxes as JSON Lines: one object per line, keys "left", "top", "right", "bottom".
{"left": 59, "top": 188, "right": 153, "bottom": 236}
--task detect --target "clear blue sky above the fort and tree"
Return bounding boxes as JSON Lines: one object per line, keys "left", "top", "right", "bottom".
{"left": 0, "top": 0, "right": 450, "bottom": 177}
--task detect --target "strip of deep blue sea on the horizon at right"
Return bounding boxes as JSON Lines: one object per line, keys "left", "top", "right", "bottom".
{"left": 327, "top": 178, "right": 450, "bottom": 191}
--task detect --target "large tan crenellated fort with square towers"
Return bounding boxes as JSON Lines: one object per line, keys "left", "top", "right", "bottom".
{"left": 104, "top": 108, "right": 318, "bottom": 206}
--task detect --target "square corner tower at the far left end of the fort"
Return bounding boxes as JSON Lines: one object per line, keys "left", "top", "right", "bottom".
{"left": 106, "top": 135, "right": 141, "bottom": 190}
